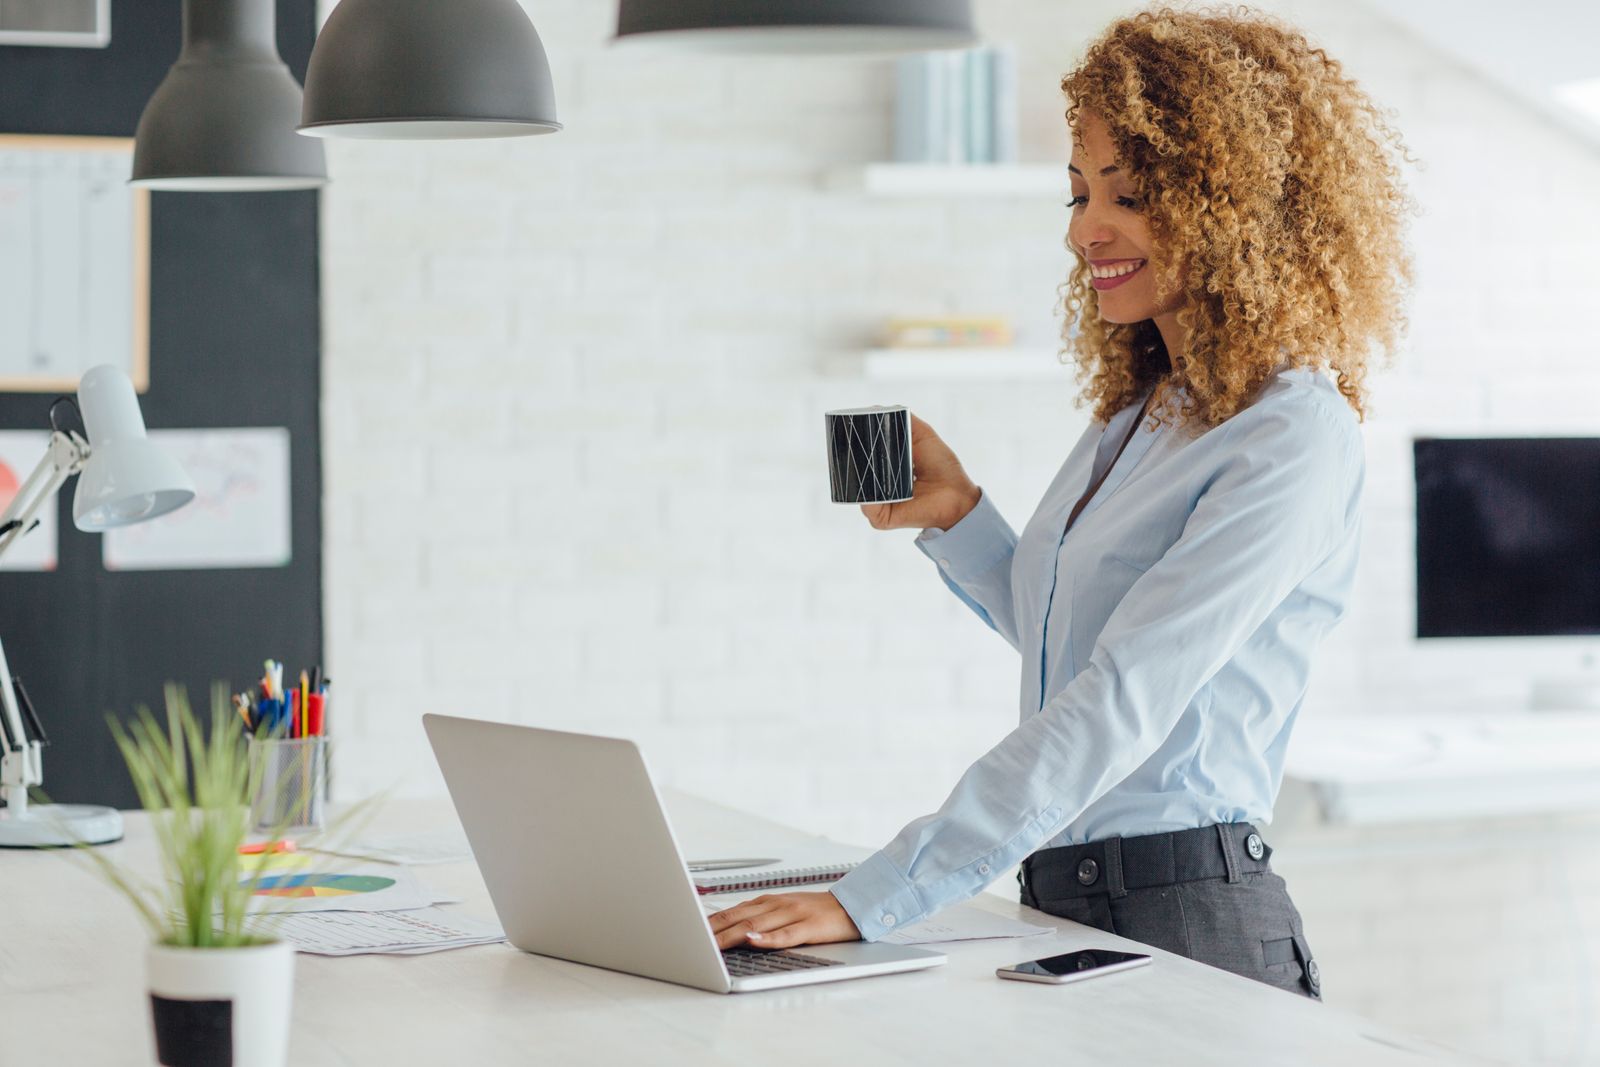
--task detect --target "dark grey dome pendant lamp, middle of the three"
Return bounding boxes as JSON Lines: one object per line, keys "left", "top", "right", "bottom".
{"left": 299, "top": 0, "right": 562, "bottom": 141}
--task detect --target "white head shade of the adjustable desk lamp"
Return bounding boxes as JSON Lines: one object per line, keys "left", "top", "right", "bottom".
{"left": 72, "top": 365, "right": 195, "bottom": 531}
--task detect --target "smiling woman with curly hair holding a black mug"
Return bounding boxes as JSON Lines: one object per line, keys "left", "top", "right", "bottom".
{"left": 712, "top": 10, "right": 1410, "bottom": 998}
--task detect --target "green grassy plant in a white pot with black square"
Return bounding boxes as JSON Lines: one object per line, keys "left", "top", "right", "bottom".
{"left": 83, "top": 685, "right": 294, "bottom": 1067}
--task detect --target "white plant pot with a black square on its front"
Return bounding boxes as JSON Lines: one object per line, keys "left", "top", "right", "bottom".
{"left": 146, "top": 941, "right": 294, "bottom": 1067}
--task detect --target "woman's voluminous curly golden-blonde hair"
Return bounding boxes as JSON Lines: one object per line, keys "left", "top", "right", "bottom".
{"left": 1061, "top": 8, "right": 1413, "bottom": 427}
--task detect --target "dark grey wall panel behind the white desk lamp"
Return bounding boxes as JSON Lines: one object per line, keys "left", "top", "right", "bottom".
{"left": 0, "top": 0, "right": 322, "bottom": 806}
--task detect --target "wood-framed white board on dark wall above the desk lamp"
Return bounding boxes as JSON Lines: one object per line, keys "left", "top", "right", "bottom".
{"left": 0, "top": 134, "right": 150, "bottom": 392}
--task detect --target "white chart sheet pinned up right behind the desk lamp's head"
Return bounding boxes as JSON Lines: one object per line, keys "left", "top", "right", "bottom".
{"left": 104, "top": 426, "right": 290, "bottom": 571}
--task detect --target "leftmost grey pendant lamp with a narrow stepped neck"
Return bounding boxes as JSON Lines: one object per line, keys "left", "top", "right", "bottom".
{"left": 131, "top": 0, "right": 328, "bottom": 192}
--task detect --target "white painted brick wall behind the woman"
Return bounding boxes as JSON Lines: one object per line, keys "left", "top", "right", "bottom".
{"left": 323, "top": 0, "right": 1600, "bottom": 1064}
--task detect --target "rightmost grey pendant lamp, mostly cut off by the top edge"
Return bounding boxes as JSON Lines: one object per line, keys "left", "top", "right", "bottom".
{"left": 613, "top": 0, "right": 978, "bottom": 54}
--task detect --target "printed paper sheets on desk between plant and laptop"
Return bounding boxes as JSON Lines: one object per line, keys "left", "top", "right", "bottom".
{"left": 253, "top": 907, "right": 506, "bottom": 957}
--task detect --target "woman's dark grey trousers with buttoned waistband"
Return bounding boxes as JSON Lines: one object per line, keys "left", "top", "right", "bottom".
{"left": 1018, "top": 822, "right": 1322, "bottom": 1000}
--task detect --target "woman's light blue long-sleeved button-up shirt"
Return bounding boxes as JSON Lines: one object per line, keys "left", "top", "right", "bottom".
{"left": 834, "top": 368, "right": 1365, "bottom": 941}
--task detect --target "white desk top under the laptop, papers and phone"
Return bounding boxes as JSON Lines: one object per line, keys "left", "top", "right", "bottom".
{"left": 0, "top": 793, "right": 1478, "bottom": 1067}
